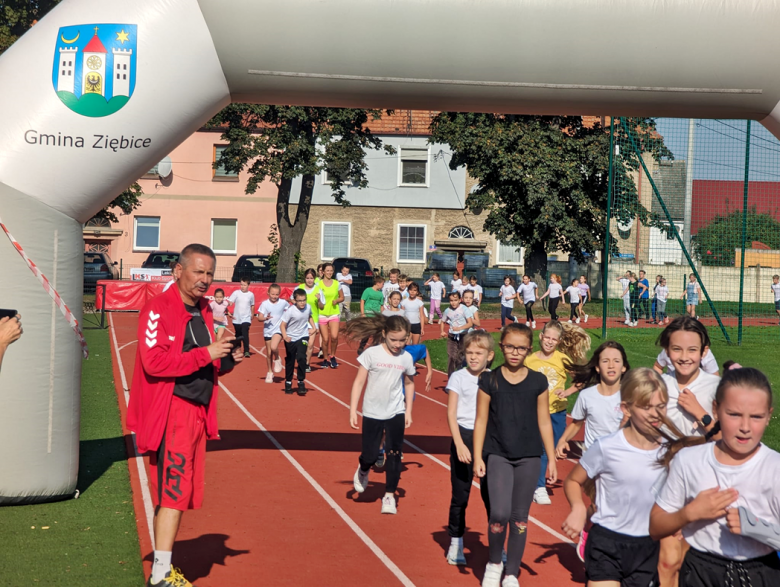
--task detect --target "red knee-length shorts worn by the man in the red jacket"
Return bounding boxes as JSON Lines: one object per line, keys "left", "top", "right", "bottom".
{"left": 149, "top": 395, "right": 206, "bottom": 511}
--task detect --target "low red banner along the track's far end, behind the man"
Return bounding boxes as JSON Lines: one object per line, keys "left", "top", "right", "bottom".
{"left": 95, "top": 279, "right": 298, "bottom": 312}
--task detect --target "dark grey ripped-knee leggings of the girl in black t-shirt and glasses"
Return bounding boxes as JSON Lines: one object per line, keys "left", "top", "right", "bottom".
{"left": 487, "top": 455, "right": 542, "bottom": 577}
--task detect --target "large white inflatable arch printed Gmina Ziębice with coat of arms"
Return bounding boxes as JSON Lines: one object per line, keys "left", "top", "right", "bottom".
{"left": 0, "top": 0, "right": 780, "bottom": 503}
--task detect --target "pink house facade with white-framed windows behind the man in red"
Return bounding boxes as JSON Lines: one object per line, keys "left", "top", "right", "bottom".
{"left": 84, "top": 131, "right": 276, "bottom": 279}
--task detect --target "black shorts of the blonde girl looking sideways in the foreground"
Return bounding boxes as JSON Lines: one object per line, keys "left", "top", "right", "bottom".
{"left": 585, "top": 524, "right": 660, "bottom": 587}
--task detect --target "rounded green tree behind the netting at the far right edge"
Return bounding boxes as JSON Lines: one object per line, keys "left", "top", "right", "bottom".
{"left": 692, "top": 207, "right": 780, "bottom": 267}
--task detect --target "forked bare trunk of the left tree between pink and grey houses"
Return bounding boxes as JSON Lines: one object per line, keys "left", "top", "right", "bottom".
{"left": 276, "top": 175, "right": 315, "bottom": 283}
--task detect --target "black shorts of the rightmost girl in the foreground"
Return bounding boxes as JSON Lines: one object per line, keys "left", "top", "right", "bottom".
{"left": 680, "top": 548, "right": 780, "bottom": 587}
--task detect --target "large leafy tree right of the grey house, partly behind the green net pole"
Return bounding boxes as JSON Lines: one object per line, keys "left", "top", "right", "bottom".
{"left": 430, "top": 112, "right": 672, "bottom": 279}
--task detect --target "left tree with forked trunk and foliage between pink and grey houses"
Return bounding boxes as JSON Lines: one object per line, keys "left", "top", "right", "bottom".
{"left": 209, "top": 104, "right": 395, "bottom": 282}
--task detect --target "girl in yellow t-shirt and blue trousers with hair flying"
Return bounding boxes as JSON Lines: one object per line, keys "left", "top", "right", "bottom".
{"left": 525, "top": 322, "right": 590, "bottom": 505}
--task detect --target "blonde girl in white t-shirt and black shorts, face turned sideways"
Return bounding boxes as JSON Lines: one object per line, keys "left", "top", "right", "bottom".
{"left": 561, "top": 367, "right": 680, "bottom": 585}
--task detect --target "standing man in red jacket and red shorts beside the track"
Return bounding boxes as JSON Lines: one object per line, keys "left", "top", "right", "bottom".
{"left": 127, "top": 244, "right": 244, "bottom": 587}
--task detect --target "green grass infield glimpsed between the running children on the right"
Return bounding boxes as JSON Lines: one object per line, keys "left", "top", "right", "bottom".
{"left": 426, "top": 325, "right": 780, "bottom": 450}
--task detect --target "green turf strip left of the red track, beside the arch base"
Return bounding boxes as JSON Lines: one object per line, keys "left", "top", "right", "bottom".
{"left": 0, "top": 330, "right": 144, "bottom": 587}
